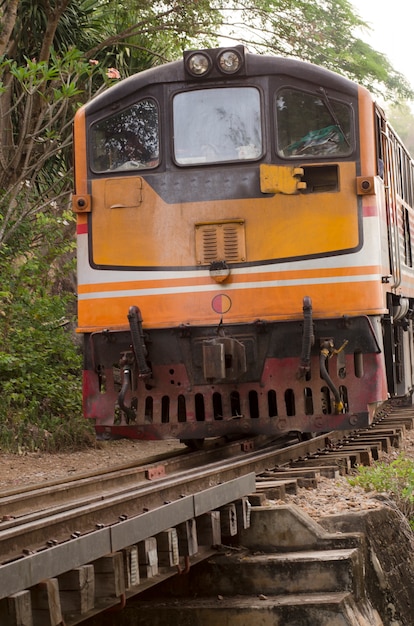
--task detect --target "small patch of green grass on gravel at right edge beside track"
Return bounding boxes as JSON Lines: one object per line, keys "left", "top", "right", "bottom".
{"left": 349, "top": 454, "right": 414, "bottom": 530}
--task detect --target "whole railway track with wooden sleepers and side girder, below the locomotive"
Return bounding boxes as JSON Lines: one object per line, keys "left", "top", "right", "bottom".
{"left": 0, "top": 407, "right": 414, "bottom": 626}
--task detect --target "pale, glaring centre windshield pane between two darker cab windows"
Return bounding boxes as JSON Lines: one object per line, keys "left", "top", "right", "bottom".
{"left": 173, "top": 87, "right": 262, "bottom": 165}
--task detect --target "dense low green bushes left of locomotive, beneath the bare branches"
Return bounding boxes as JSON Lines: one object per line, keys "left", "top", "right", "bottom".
{"left": 0, "top": 238, "right": 93, "bottom": 451}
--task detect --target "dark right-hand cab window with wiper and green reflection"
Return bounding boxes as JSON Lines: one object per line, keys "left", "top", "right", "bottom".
{"left": 276, "top": 88, "right": 352, "bottom": 158}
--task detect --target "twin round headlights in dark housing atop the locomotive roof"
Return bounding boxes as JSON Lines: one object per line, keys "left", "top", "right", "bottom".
{"left": 184, "top": 46, "right": 245, "bottom": 78}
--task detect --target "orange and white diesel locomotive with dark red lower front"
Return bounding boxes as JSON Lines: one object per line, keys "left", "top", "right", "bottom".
{"left": 73, "top": 46, "right": 414, "bottom": 445}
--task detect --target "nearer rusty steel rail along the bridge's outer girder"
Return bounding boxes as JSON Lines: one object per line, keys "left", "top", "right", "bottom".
{"left": 0, "top": 428, "right": 336, "bottom": 562}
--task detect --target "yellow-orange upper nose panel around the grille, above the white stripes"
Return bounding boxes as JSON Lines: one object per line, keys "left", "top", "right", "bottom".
{"left": 92, "top": 163, "right": 360, "bottom": 267}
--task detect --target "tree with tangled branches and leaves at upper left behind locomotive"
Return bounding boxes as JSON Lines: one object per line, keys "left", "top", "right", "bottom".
{"left": 0, "top": 0, "right": 223, "bottom": 252}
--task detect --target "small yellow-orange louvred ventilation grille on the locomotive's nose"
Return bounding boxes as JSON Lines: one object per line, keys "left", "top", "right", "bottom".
{"left": 195, "top": 220, "right": 246, "bottom": 265}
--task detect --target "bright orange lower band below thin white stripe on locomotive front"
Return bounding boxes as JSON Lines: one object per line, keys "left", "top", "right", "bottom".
{"left": 79, "top": 280, "right": 383, "bottom": 331}
